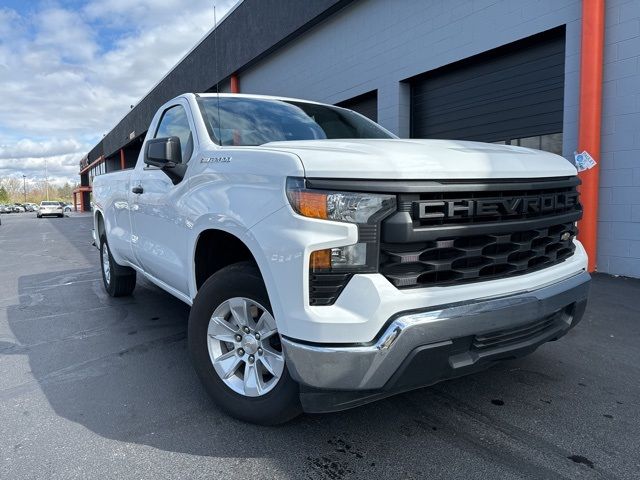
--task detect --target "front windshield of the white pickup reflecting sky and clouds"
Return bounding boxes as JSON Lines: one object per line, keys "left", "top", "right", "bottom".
{"left": 198, "top": 97, "right": 394, "bottom": 146}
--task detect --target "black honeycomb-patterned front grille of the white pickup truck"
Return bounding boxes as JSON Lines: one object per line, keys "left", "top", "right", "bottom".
{"left": 380, "top": 179, "right": 582, "bottom": 288}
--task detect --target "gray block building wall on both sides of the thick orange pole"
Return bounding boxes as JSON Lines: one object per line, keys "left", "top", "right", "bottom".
{"left": 240, "top": 0, "right": 640, "bottom": 277}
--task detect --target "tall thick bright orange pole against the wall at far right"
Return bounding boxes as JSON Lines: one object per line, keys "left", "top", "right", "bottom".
{"left": 578, "top": 0, "right": 605, "bottom": 272}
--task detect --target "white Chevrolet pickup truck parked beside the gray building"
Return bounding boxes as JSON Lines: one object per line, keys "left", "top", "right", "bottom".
{"left": 93, "top": 94, "right": 590, "bottom": 424}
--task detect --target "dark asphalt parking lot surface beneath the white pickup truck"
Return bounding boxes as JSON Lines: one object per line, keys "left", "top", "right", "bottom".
{"left": 0, "top": 213, "right": 640, "bottom": 479}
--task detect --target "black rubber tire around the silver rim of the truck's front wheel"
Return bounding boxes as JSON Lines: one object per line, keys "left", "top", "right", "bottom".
{"left": 188, "top": 263, "right": 300, "bottom": 425}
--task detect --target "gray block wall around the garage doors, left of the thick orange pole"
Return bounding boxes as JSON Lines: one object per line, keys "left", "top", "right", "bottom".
{"left": 240, "top": 0, "right": 581, "bottom": 154}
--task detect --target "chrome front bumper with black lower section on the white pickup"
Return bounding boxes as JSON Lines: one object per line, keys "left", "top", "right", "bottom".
{"left": 282, "top": 272, "right": 591, "bottom": 391}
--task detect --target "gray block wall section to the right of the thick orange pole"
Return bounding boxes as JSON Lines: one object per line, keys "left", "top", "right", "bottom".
{"left": 598, "top": 0, "right": 640, "bottom": 277}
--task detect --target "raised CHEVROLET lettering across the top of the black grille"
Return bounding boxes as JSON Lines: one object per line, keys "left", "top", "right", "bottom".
{"left": 413, "top": 192, "right": 578, "bottom": 220}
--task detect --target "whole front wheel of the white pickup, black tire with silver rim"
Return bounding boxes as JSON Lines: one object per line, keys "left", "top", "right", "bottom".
{"left": 188, "top": 262, "right": 302, "bottom": 425}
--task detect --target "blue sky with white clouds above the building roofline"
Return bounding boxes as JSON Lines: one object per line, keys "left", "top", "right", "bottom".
{"left": 0, "top": 0, "right": 236, "bottom": 184}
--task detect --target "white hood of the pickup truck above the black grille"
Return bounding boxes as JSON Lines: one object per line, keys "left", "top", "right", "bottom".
{"left": 263, "top": 139, "right": 576, "bottom": 180}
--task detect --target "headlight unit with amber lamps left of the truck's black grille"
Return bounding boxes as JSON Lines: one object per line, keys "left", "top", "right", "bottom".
{"left": 287, "top": 178, "right": 396, "bottom": 273}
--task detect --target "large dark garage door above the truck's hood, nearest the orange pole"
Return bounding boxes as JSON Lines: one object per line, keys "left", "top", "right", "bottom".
{"left": 409, "top": 27, "right": 565, "bottom": 153}
